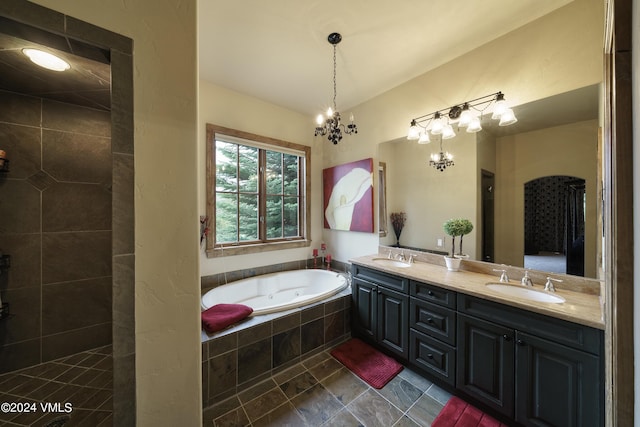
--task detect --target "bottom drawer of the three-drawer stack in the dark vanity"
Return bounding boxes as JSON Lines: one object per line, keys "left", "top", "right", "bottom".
{"left": 409, "top": 329, "right": 456, "bottom": 386}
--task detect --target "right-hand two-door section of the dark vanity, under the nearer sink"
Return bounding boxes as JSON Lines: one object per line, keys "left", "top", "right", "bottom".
{"left": 456, "top": 295, "right": 604, "bottom": 427}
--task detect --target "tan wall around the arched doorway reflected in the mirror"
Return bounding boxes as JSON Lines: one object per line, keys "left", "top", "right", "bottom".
{"left": 495, "top": 120, "right": 598, "bottom": 277}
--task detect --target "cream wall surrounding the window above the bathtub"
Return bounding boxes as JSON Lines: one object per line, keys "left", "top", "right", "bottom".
{"left": 198, "top": 81, "right": 322, "bottom": 276}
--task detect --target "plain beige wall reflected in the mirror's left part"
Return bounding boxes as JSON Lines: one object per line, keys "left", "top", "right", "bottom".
{"left": 379, "top": 133, "right": 479, "bottom": 258}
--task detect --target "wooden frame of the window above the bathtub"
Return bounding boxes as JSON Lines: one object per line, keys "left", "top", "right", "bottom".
{"left": 206, "top": 123, "right": 311, "bottom": 258}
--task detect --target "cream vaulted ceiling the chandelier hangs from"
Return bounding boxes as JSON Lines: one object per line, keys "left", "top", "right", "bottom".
{"left": 198, "top": 0, "right": 571, "bottom": 116}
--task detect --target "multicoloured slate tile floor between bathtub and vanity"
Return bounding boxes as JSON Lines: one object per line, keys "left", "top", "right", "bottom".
{"left": 203, "top": 344, "right": 451, "bottom": 427}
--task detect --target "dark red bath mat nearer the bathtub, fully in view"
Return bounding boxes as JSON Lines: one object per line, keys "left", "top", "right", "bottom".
{"left": 331, "top": 338, "right": 403, "bottom": 388}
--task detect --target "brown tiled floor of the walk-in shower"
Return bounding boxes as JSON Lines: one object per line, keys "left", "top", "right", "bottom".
{"left": 0, "top": 346, "right": 113, "bottom": 427}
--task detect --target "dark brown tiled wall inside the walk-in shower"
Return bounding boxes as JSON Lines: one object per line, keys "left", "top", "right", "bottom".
{"left": 0, "top": 91, "right": 112, "bottom": 372}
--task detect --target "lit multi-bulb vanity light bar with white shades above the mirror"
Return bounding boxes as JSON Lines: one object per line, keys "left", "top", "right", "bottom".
{"left": 407, "top": 92, "right": 518, "bottom": 143}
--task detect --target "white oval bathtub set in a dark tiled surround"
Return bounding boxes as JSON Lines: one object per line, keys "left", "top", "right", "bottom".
{"left": 201, "top": 270, "right": 349, "bottom": 316}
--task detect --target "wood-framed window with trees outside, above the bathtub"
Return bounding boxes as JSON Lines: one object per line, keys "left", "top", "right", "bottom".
{"left": 207, "top": 124, "right": 311, "bottom": 257}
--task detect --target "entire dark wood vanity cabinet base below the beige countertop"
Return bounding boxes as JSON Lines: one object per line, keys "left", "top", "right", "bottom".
{"left": 352, "top": 264, "right": 604, "bottom": 427}
